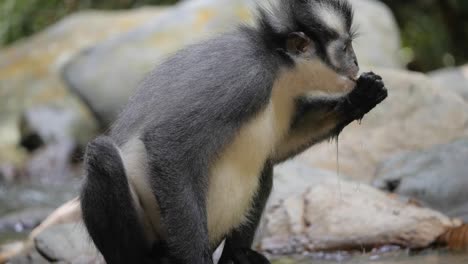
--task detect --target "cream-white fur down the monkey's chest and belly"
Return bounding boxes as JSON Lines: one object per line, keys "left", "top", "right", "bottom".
{"left": 207, "top": 102, "right": 286, "bottom": 243}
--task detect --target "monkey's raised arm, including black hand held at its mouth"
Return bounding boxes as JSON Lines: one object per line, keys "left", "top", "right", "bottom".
{"left": 274, "top": 73, "right": 387, "bottom": 163}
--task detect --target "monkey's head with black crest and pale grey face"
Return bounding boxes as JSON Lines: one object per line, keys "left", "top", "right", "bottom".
{"left": 260, "top": 0, "right": 359, "bottom": 79}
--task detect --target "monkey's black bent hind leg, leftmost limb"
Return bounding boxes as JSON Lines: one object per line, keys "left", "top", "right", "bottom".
{"left": 81, "top": 137, "right": 151, "bottom": 264}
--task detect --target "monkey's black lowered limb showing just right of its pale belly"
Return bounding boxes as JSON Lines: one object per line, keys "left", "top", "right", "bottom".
{"left": 219, "top": 162, "right": 273, "bottom": 264}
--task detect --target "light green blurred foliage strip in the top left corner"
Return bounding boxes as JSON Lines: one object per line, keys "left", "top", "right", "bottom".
{"left": 0, "top": 0, "right": 177, "bottom": 46}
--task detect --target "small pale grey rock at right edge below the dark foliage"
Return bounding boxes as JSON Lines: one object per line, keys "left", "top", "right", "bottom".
{"left": 429, "top": 65, "right": 468, "bottom": 101}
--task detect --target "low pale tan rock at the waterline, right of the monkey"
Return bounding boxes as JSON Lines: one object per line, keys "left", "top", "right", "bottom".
{"left": 260, "top": 181, "right": 460, "bottom": 254}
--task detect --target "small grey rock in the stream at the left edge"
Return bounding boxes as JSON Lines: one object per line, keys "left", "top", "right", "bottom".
{"left": 0, "top": 208, "right": 52, "bottom": 234}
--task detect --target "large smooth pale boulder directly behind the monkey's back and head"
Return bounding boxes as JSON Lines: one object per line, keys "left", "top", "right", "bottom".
{"left": 63, "top": 0, "right": 401, "bottom": 125}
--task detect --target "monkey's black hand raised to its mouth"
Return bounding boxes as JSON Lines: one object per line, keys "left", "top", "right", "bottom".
{"left": 342, "top": 72, "right": 388, "bottom": 122}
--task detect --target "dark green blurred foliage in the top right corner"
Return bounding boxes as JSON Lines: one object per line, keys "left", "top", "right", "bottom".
{"left": 382, "top": 0, "right": 468, "bottom": 72}
